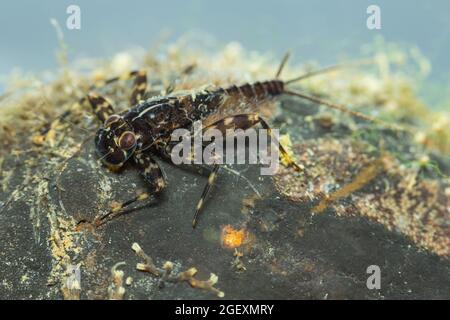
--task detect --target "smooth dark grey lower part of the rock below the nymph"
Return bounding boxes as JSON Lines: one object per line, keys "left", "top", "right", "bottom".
{"left": 0, "top": 95, "right": 450, "bottom": 299}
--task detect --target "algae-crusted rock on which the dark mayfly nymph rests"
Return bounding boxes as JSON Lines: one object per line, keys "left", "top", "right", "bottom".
{"left": 0, "top": 44, "right": 450, "bottom": 299}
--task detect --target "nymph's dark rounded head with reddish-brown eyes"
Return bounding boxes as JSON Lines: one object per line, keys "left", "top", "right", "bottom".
{"left": 95, "top": 114, "right": 137, "bottom": 167}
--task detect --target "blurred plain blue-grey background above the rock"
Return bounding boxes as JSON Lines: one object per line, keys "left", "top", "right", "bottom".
{"left": 0, "top": 0, "right": 450, "bottom": 107}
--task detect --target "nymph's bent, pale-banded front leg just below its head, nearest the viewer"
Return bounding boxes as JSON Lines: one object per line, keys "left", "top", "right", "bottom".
{"left": 96, "top": 152, "right": 166, "bottom": 226}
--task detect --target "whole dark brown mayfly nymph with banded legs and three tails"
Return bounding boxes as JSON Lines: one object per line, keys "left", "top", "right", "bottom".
{"left": 87, "top": 56, "right": 384, "bottom": 227}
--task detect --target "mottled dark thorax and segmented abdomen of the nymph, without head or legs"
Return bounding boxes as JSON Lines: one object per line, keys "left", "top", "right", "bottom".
{"left": 123, "top": 81, "right": 283, "bottom": 152}
